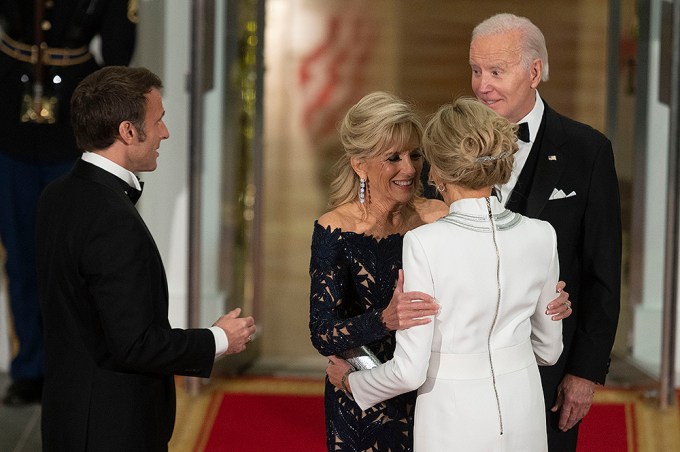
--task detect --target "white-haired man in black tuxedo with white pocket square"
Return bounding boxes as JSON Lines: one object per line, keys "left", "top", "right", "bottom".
{"left": 470, "top": 14, "right": 621, "bottom": 452}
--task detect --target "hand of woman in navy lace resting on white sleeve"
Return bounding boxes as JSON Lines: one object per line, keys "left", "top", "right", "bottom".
{"left": 381, "top": 270, "right": 439, "bottom": 331}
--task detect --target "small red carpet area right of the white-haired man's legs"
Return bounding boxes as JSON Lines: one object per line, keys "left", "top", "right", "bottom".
{"left": 576, "top": 403, "right": 638, "bottom": 452}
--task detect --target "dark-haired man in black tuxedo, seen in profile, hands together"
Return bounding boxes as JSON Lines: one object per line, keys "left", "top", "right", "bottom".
{"left": 36, "top": 66, "right": 255, "bottom": 452}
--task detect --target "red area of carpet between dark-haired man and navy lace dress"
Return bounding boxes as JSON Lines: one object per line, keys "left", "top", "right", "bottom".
{"left": 196, "top": 393, "right": 326, "bottom": 452}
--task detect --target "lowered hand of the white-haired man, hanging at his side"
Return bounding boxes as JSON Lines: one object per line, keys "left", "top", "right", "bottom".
{"left": 551, "top": 374, "right": 596, "bottom": 432}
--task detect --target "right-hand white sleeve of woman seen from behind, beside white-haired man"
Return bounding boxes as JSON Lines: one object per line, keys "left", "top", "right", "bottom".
{"left": 531, "top": 227, "right": 563, "bottom": 366}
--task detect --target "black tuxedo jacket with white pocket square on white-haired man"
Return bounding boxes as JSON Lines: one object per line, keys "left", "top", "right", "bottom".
{"left": 506, "top": 104, "right": 621, "bottom": 428}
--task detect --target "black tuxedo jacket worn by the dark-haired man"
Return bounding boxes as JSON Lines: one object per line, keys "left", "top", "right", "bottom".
{"left": 37, "top": 160, "right": 215, "bottom": 452}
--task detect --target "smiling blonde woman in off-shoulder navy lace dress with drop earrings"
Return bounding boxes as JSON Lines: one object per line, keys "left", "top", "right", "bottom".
{"left": 309, "top": 92, "right": 446, "bottom": 451}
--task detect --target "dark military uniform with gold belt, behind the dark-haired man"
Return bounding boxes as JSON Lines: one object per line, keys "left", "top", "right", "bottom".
{"left": 0, "top": 0, "right": 136, "bottom": 405}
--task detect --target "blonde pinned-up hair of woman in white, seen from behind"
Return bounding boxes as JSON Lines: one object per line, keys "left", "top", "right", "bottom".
{"left": 423, "top": 97, "right": 518, "bottom": 190}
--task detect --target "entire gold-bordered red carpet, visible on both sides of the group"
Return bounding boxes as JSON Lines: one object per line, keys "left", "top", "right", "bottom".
{"left": 194, "top": 379, "right": 639, "bottom": 452}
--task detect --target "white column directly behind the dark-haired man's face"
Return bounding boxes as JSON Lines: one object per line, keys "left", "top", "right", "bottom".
{"left": 133, "top": 0, "right": 191, "bottom": 328}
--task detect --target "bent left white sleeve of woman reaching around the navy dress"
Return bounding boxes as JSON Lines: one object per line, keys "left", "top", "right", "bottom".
{"left": 349, "top": 232, "right": 435, "bottom": 410}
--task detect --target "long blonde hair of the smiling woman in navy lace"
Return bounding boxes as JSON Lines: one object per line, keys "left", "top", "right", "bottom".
{"left": 328, "top": 91, "right": 423, "bottom": 208}
